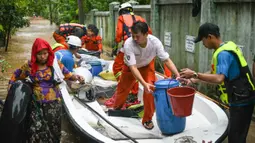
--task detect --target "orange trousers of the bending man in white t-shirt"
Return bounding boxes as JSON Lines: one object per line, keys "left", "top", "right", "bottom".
{"left": 113, "top": 60, "right": 156, "bottom": 123}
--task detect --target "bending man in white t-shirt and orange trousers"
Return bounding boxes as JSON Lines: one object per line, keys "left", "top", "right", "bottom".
{"left": 114, "top": 21, "right": 180, "bottom": 129}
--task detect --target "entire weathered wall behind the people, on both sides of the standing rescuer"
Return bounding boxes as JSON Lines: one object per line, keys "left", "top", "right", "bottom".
{"left": 85, "top": 0, "right": 255, "bottom": 72}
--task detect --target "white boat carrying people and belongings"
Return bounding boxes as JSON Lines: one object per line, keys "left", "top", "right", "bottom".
{"left": 60, "top": 60, "right": 228, "bottom": 143}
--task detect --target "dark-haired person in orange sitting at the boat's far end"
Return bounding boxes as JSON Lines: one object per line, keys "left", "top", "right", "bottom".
{"left": 82, "top": 24, "right": 103, "bottom": 58}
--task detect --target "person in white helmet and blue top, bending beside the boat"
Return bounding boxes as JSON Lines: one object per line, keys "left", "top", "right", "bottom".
{"left": 55, "top": 35, "right": 81, "bottom": 72}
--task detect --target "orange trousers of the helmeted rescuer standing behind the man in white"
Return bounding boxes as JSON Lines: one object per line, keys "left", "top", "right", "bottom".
{"left": 112, "top": 51, "right": 139, "bottom": 94}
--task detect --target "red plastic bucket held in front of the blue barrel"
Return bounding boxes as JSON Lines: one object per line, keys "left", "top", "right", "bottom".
{"left": 167, "top": 87, "right": 196, "bottom": 117}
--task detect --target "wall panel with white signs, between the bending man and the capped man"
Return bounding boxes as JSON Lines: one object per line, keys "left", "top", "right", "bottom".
{"left": 158, "top": 3, "right": 200, "bottom": 69}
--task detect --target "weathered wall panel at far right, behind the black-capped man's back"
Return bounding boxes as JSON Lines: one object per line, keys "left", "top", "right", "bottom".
{"left": 215, "top": 2, "right": 255, "bottom": 68}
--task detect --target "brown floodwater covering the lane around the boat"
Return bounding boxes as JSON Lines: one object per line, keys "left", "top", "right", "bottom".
{"left": 0, "top": 18, "right": 255, "bottom": 143}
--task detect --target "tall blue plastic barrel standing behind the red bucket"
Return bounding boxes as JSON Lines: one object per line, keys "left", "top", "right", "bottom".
{"left": 154, "top": 79, "right": 186, "bottom": 135}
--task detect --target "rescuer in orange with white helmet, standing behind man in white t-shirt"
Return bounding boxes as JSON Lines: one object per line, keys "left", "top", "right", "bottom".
{"left": 104, "top": 2, "right": 152, "bottom": 108}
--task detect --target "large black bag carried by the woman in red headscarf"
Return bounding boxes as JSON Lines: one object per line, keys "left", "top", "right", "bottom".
{"left": 0, "top": 80, "right": 32, "bottom": 143}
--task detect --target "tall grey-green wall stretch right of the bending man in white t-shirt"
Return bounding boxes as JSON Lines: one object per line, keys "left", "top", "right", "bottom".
{"left": 151, "top": 0, "right": 255, "bottom": 72}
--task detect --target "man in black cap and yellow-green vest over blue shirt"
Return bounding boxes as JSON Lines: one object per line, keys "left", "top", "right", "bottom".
{"left": 180, "top": 23, "right": 255, "bottom": 143}
